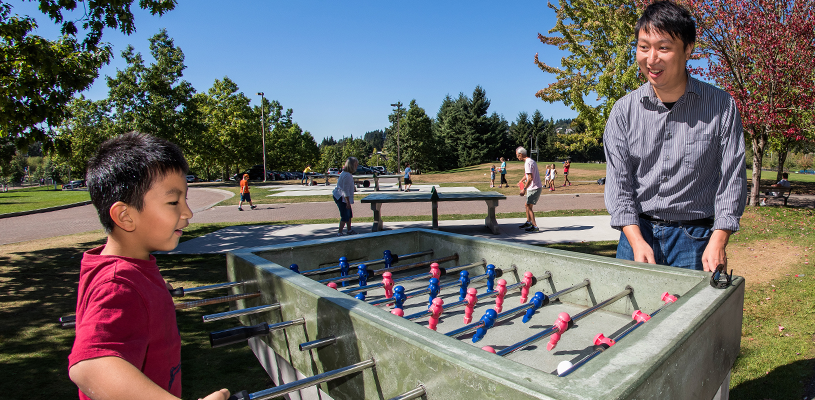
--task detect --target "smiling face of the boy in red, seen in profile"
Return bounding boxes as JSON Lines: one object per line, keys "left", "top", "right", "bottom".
{"left": 131, "top": 172, "right": 192, "bottom": 252}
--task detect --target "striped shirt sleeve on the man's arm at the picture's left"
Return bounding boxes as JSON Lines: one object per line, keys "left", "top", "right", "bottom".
{"left": 603, "top": 102, "right": 639, "bottom": 229}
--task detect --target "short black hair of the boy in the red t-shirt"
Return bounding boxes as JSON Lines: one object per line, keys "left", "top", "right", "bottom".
{"left": 85, "top": 132, "right": 189, "bottom": 233}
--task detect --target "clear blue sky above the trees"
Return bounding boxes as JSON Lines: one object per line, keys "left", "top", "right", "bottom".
{"left": 11, "top": 0, "right": 576, "bottom": 142}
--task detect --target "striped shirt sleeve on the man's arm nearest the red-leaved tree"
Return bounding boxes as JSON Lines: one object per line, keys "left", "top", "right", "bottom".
{"left": 713, "top": 98, "right": 747, "bottom": 232}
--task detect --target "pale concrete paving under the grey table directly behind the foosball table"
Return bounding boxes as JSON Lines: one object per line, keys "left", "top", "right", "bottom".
{"left": 163, "top": 215, "right": 620, "bottom": 254}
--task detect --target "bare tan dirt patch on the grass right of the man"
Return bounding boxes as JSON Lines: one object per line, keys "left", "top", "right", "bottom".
{"left": 727, "top": 239, "right": 805, "bottom": 285}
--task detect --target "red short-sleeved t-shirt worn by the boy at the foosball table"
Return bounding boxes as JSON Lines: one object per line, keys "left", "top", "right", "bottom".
{"left": 68, "top": 246, "right": 181, "bottom": 400}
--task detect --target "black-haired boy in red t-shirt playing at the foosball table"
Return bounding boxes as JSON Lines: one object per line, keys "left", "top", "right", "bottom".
{"left": 68, "top": 132, "right": 229, "bottom": 400}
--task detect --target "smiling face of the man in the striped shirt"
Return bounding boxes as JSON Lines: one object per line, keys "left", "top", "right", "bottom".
{"left": 637, "top": 29, "right": 693, "bottom": 92}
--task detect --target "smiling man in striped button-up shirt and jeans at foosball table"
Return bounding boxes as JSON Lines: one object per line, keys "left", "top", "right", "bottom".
{"left": 603, "top": 1, "right": 747, "bottom": 271}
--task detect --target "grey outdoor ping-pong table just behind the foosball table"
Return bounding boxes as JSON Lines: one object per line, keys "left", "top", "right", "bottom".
{"left": 361, "top": 192, "right": 507, "bottom": 235}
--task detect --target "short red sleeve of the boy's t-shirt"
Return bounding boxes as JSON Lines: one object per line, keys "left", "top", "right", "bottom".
{"left": 68, "top": 281, "right": 149, "bottom": 369}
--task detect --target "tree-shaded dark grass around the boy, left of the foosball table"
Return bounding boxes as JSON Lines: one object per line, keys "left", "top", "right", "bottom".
{"left": 0, "top": 240, "right": 270, "bottom": 399}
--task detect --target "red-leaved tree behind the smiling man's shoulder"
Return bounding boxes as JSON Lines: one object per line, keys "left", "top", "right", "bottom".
{"left": 683, "top": 0, "right": 815, "bottom": 205}
